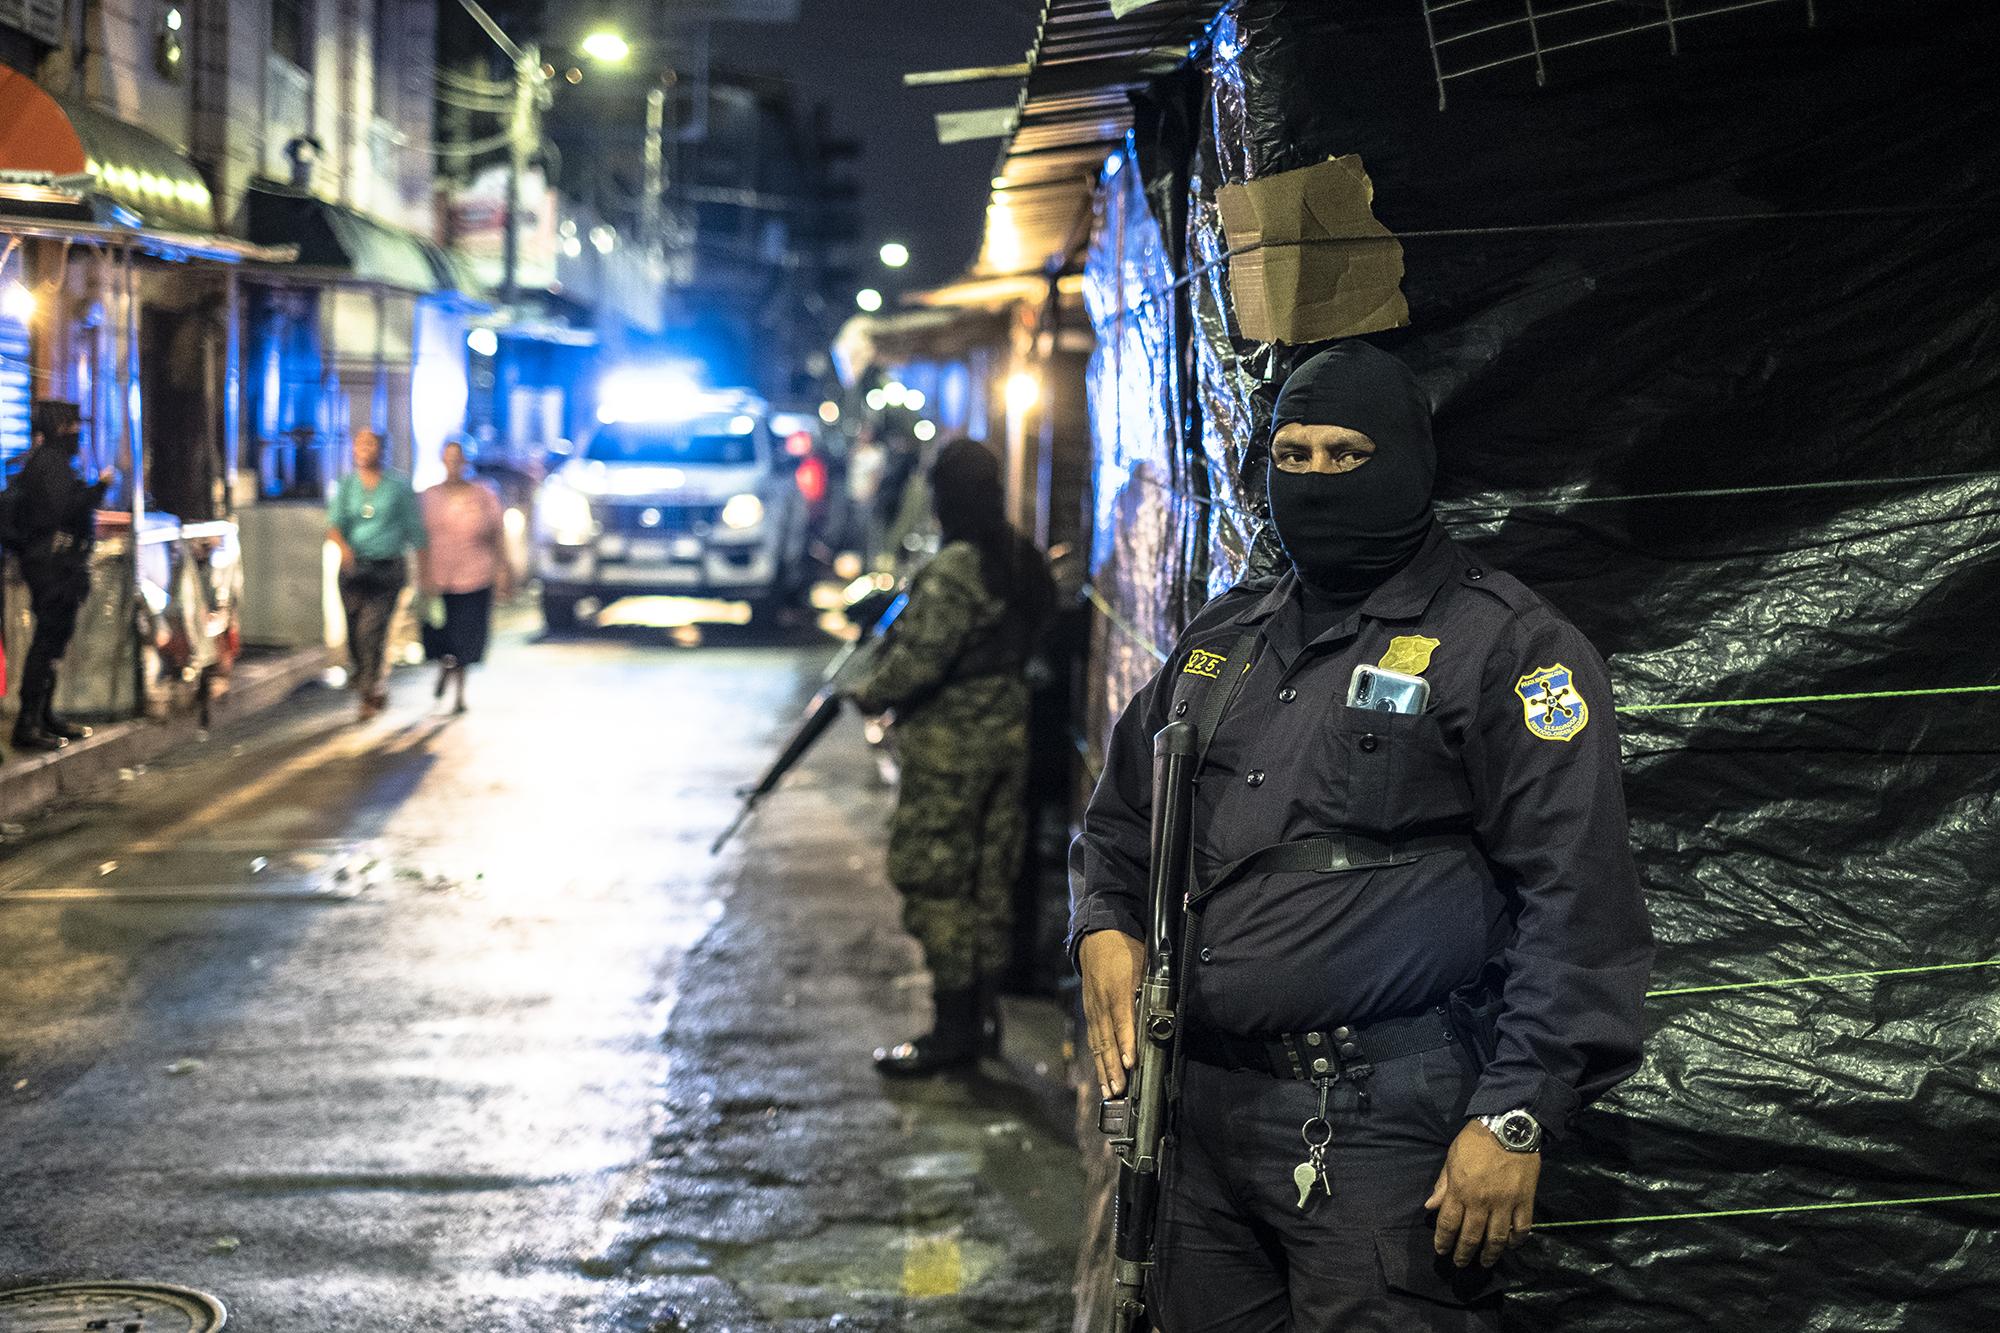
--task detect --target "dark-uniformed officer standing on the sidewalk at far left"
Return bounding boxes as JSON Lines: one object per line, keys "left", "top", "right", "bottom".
{"left": 12, "top": 398, "right": 112, "bottom": 751}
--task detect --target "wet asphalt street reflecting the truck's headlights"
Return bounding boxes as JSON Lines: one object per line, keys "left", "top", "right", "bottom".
{"left": 0, "top": 608, "right": 1082, "bottom": 1333}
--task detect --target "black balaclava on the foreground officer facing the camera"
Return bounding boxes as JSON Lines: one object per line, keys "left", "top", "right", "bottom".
{"left": 1266, "top": 342, "right": 1438, "bottom": 600}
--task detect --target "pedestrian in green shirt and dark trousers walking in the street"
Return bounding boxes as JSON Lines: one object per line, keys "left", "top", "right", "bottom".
{"left": 326, "top": 430, "right": 424, "bottom": 721}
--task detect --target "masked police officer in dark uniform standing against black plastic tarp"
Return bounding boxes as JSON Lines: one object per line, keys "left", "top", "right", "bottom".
{"left": 1070, "top": 342, "right": 1652, "bottom": 1333}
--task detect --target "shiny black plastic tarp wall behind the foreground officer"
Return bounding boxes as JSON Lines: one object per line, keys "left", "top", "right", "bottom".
{"left": 1088, "top": 0, "right": 2000, "bottom": 1333}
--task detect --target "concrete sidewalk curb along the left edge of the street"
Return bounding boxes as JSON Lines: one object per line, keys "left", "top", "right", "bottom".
{"left": 0, "top": 648, "right": 326, "bottom": 821}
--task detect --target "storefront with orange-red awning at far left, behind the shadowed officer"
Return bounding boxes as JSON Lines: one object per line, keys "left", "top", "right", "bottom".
{"left": 0, "top": 70, "right": 288, "bottom": 717}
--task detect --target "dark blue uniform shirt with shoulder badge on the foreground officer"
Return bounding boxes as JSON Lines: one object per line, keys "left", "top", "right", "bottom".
{"left": 1070, "top": 528, "right": 1652, "bottom": 1133}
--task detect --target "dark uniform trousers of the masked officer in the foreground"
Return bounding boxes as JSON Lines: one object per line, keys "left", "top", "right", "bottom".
{"left": 1152, "top": 1047, "right": 1508, "bottom": 1333}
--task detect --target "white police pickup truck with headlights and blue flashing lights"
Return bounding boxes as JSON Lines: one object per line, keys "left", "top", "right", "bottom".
{"left": 532, "top": 384, "right": 808, "bottom": 630}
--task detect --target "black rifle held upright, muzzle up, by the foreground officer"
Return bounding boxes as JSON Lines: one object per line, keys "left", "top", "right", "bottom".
{"left": 1098, "top": 723, "right": 1196, "bottom": 1333}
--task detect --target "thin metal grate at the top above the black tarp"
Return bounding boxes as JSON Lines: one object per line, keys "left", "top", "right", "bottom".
{"left": 1420, "top": 0, "right": 1820, "bottom": 110}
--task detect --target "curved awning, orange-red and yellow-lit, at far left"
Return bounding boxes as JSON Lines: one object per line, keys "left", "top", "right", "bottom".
{"left": 0, "top": 68, "right": 216, "bottom": 232}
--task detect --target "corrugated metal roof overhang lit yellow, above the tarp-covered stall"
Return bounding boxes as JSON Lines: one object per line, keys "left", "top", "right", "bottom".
{"left": 968, "top": 0, "right": 1222, "bottom": 278}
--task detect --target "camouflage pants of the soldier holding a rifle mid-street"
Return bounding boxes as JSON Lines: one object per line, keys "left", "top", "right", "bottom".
{"left": 888, "top": 753, "right": 1028, "bottom": 991}
